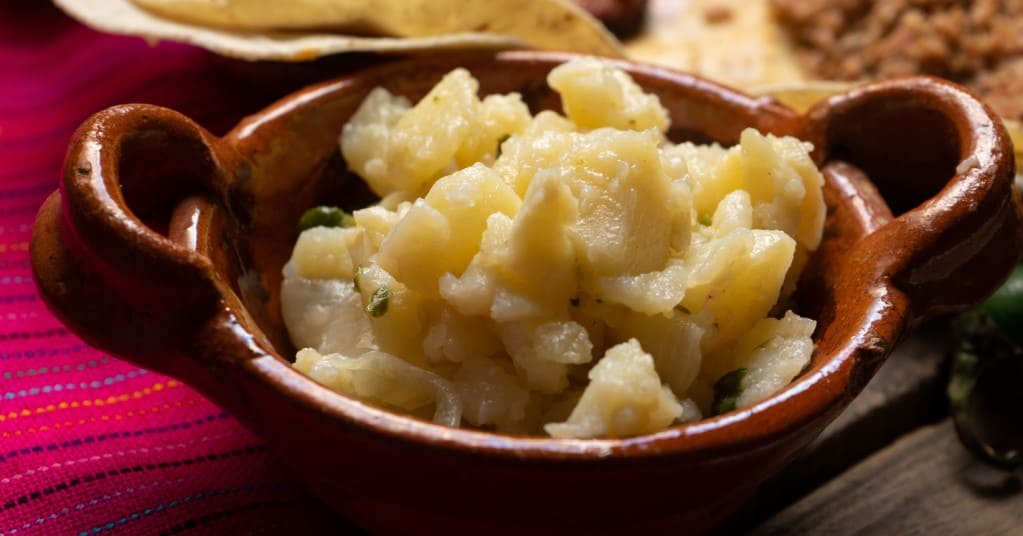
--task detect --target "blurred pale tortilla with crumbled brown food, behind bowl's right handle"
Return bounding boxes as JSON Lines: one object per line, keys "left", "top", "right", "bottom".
{"left": 626, "top": 0, "right": 1023, "bottom": 120}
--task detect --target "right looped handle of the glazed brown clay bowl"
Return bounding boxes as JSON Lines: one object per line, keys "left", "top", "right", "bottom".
{"left": 802, "top": 77, "right": 1023, "bottom": 321}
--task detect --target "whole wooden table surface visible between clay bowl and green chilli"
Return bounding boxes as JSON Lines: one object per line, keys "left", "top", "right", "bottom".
{"left": 716, "top": 320, "right": 1023, "bottom": 536}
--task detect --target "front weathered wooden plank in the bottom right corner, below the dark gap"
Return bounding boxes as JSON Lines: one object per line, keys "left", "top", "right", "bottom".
{"left": 751, "top": 419, "right": 1023, "bottom": 535}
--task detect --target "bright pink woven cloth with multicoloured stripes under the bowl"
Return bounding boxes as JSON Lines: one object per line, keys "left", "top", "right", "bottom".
{"left": 0, "top": 2, "right": 351, "bottom": 536}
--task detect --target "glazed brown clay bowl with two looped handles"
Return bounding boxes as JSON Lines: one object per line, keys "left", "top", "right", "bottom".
{"left": 32, "top": 52, "right": 1023, "bottom": 533}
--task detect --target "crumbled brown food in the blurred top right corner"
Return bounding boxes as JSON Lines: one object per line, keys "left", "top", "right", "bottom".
{"left": 770, "top": 0, "right": 1023, "bottom": 119}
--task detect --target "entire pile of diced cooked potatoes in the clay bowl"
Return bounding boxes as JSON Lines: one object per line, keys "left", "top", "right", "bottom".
{"left": 281, "top": 58, "right": 825, "bottom": 438}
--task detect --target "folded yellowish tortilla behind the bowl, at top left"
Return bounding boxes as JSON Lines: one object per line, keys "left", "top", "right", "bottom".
{"left": 53, "top": 0, "right": 622, "bottom": 60}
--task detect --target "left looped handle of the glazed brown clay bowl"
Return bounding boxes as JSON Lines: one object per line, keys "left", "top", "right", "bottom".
{"left": 32, "top": 104, "right": 230, "bottom": 373}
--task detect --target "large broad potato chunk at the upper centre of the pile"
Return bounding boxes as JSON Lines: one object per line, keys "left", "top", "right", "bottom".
{"left": 503, "top": 127, "right": 691, "bottom": 276}
